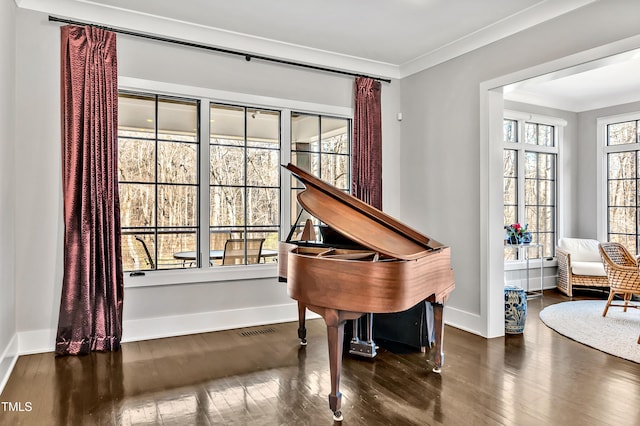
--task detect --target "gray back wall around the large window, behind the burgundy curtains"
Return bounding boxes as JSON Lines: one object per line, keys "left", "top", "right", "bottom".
{"left": 11, "top": 9, "right": 400, "bottom": 352}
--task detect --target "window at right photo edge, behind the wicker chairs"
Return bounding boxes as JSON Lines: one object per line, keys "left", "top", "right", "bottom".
{"left": 598, "top": 114, "right": 640, "bottom": 255}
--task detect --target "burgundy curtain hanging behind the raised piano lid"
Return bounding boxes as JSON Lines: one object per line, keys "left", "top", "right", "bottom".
{"left": 351, "top": 77, "right": 382, "bottom": 209}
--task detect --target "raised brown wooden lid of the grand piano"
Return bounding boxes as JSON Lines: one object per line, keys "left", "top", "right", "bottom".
{"left": 283, "top": 163, "right": 444, "bottom": 260}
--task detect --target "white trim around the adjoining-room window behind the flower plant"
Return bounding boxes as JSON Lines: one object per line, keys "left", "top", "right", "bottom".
{"left": 502, "top": 109, "right": 567, "bottom": 271}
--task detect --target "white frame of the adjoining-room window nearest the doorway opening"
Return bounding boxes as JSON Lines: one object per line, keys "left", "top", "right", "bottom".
{"left": 501, "top": 109, "right": 567, "bottom": 271}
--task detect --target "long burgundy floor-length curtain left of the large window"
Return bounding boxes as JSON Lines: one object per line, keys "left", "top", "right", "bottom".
{"left": 56, "top": 26, "right": 123, "bottom": 355}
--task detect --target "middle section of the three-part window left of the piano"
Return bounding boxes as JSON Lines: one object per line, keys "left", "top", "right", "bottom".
{"left": 209, "top": 104, "right": 280, "bottom": 264}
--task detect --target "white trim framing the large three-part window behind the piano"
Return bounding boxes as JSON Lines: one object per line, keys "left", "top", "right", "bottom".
{"left": 118, "top": 76, "right": 353, "bottom": 288}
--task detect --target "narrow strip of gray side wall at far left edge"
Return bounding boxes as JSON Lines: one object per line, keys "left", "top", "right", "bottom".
{"left": 0, "top": 1, "right": 17, "bottom": 390}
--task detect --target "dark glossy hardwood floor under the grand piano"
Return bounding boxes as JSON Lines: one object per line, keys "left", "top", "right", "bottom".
{"left": 0, "top": 291, "right": 640, "bottom": 426}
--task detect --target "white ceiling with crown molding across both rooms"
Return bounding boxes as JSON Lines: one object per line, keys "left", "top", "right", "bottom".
{"left": 15, "top": 0, "right": 640, "bottom": 111}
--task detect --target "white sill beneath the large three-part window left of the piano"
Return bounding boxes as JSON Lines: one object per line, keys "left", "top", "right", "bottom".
{"left": 124, "top": 263, "right": 278, "bottom": 288}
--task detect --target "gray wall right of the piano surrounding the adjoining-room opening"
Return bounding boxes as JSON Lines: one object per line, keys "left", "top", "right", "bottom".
{"left": 400, "top": 0, "right": 640, "bottom": 324}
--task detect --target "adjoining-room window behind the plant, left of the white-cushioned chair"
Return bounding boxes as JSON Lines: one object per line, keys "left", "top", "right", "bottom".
{"left": 503, "top": 114, "right": 560, "bottom": 260}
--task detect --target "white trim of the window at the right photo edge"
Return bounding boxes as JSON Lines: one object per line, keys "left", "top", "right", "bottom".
{"left": 596, "top": 111, "right": 640, "bottom": 241}
